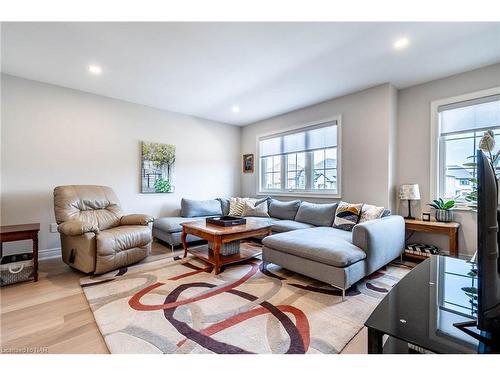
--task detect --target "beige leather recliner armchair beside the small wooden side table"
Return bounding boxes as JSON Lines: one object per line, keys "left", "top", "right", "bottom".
{"left": 54, "top": 185, "right": 153, "bottom": 274}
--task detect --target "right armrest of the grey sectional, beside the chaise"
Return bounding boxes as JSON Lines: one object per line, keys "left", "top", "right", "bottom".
{"left": 352, "top": 215, "right": 405, "bottom": 272}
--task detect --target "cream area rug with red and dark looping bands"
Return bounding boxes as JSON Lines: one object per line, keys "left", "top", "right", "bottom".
{"left": 80, "top": 248, "right": 409, "bottom": 354}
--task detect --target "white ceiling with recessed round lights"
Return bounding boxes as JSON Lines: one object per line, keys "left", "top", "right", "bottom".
{"left": 1, "top": 22, "right": 500, "bottom": 125}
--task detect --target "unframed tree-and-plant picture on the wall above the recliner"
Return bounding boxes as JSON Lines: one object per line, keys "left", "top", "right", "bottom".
{"left": 141, "top": 142, "right": 175, "bottom": 193}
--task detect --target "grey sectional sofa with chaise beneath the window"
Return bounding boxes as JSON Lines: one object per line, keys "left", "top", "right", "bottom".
{"left": 153, "top": 197, "right": 405, "bottom": 299}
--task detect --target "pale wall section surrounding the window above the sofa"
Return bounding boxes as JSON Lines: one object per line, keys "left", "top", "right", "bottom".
{"left": 241, "top": 84, "right": 397, "bottom": 212}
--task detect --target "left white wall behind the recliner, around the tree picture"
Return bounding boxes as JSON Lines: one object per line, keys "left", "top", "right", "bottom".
{"left": 1, "top": 75, "right": 241, "bottom": 256}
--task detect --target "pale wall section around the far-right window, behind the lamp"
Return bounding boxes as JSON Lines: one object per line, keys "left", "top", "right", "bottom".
{"left": 397, "top": 64, "right": 500, "bottom": 255}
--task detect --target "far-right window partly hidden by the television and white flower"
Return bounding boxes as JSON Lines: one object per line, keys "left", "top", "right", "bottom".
{"left": 437, "top": 94, "right": 500, "bottom": 202}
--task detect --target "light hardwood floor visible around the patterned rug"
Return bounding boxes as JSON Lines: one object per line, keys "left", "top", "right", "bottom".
{"left": 0, "top": 242, "right": 367, "bottom": 354}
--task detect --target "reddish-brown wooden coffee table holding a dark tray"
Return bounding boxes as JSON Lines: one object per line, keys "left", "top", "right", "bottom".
{"left": 181, "top": 219, "right": 271, "bottom": 275}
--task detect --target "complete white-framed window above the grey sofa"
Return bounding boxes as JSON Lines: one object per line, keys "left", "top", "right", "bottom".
{"left": 258, "top": 120, "right": 340, "bottom": 196}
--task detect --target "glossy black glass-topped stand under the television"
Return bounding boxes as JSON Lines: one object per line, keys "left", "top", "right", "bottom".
{"left": 365, "top": 255, "right": 498, "bottom": 354}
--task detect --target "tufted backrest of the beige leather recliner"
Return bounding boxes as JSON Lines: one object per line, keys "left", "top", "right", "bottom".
{"left": 54, "top": 185, "right": 123, "bottom": 230}
